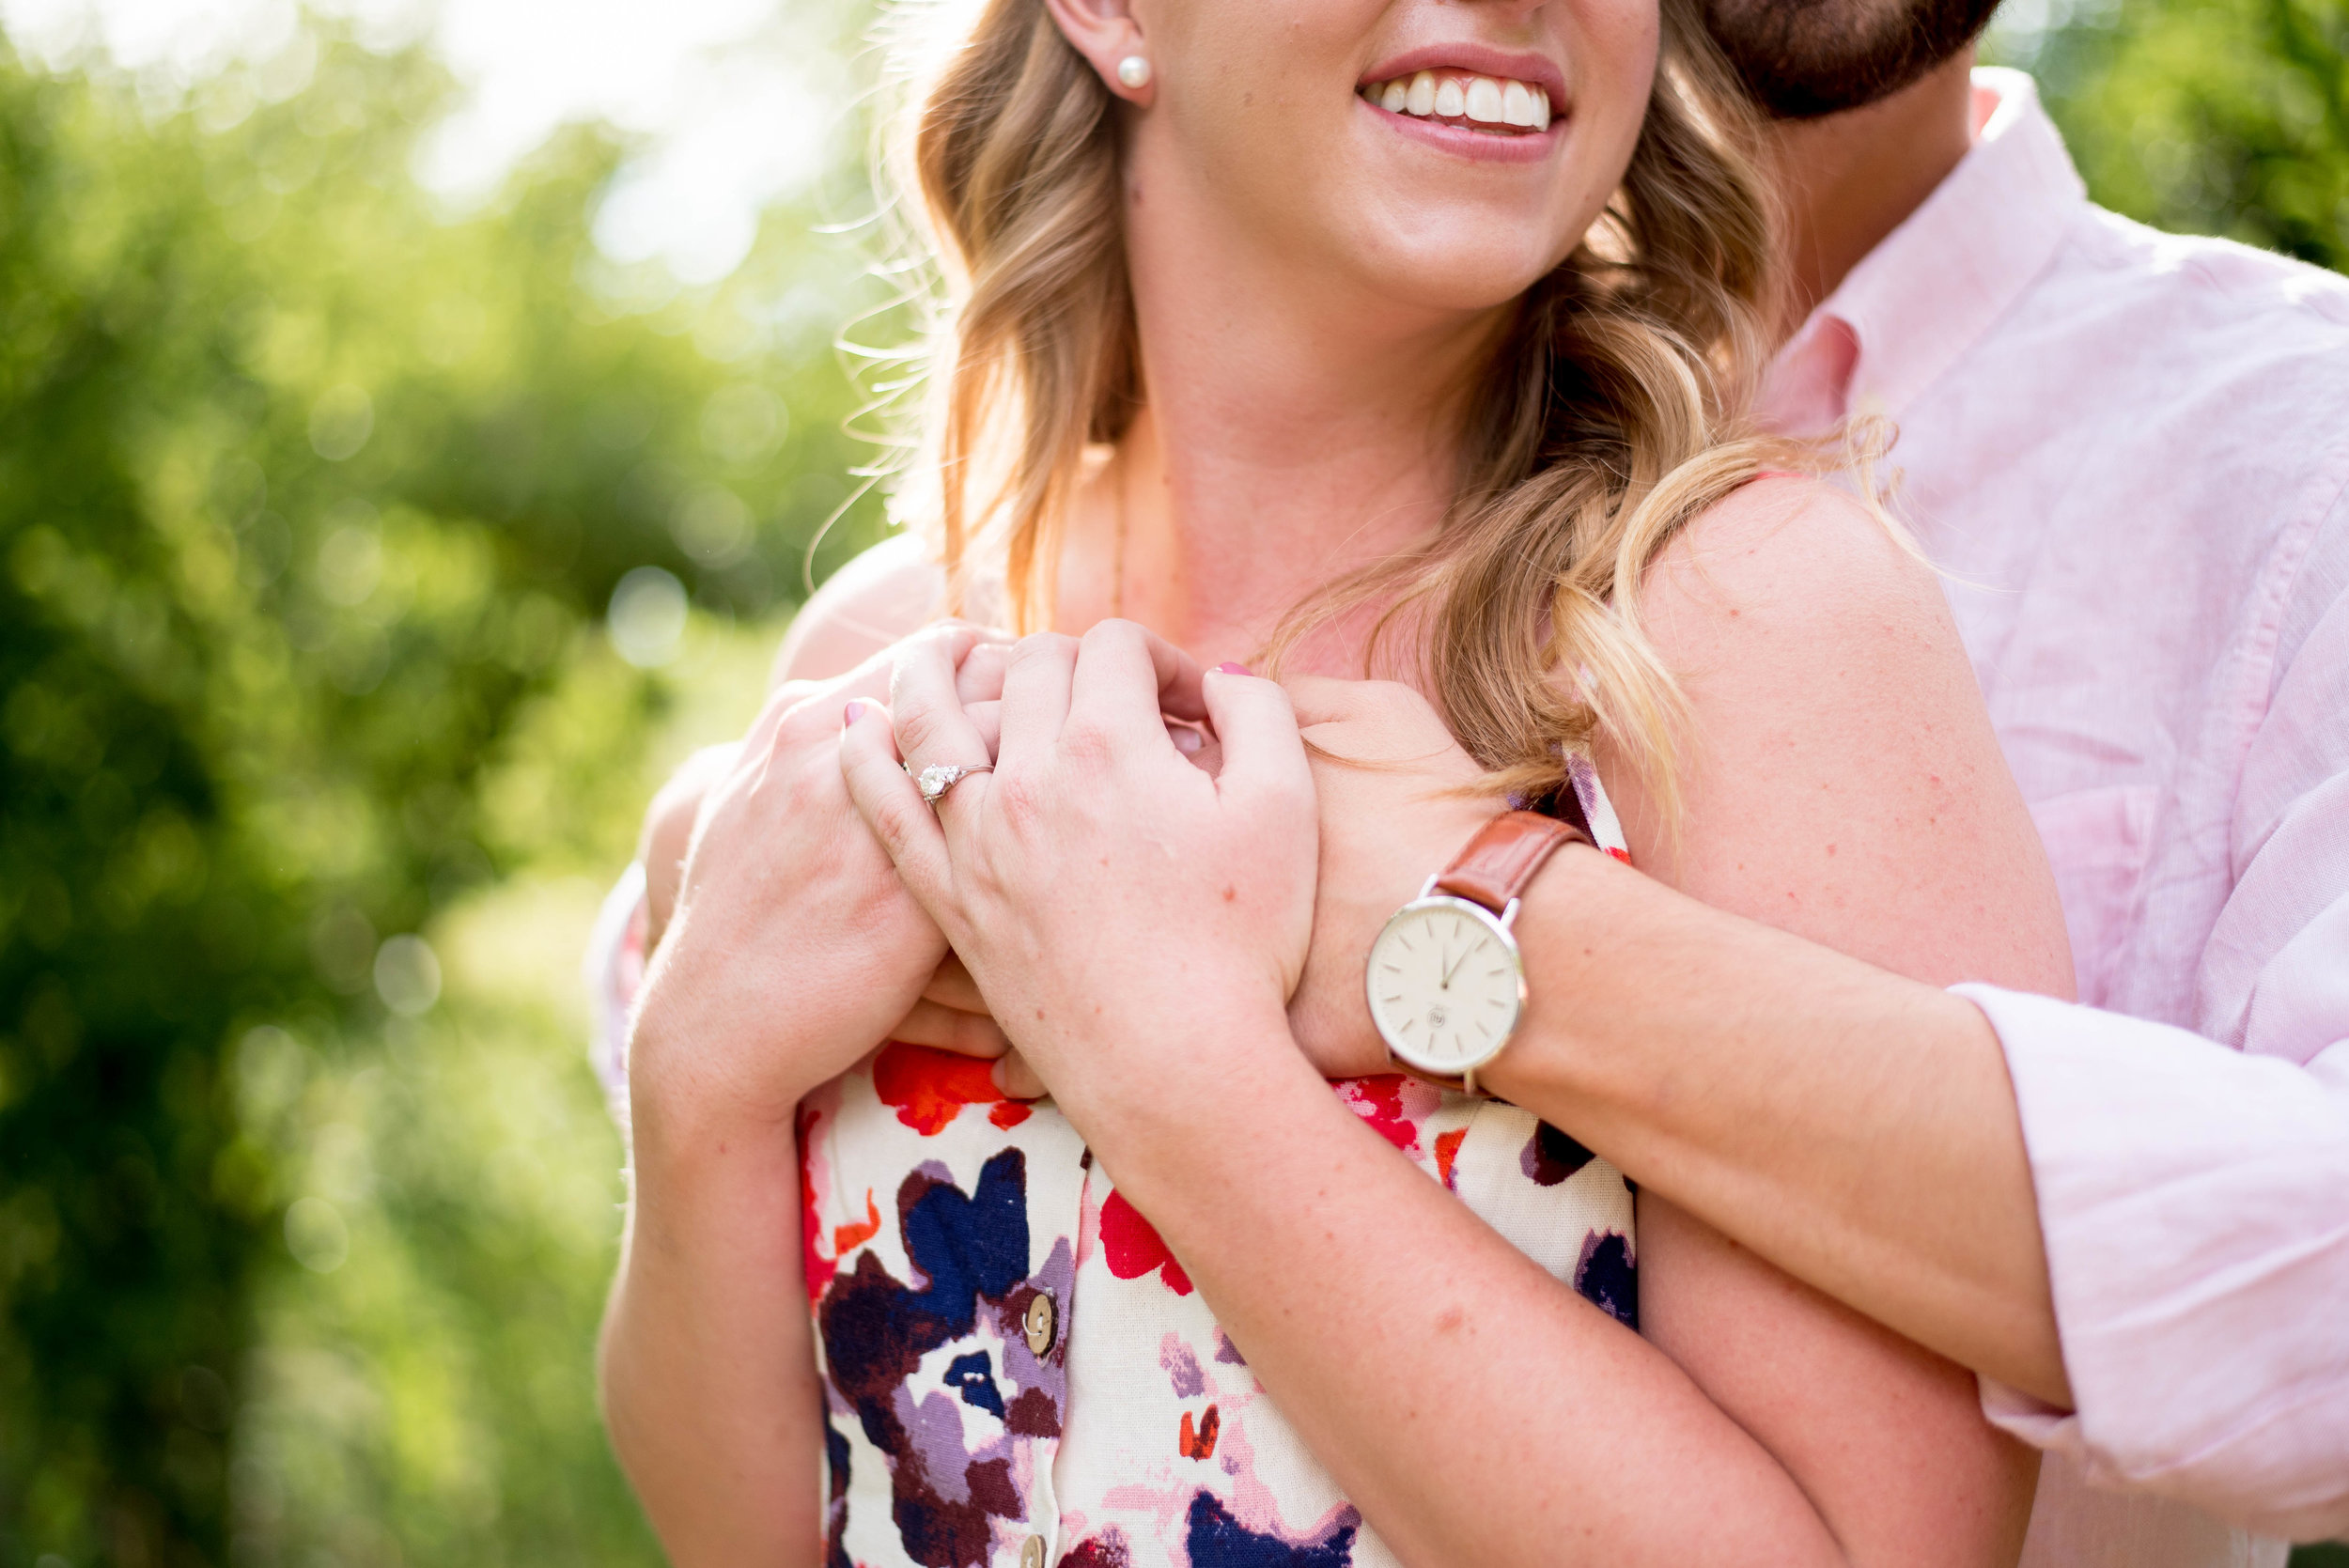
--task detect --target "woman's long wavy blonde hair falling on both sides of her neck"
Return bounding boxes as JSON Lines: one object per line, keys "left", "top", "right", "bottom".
{"left": 888, "top": 0, "right": 1809, "bottom": 815}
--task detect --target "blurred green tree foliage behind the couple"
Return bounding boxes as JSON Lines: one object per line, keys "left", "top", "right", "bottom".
{"left": 0, "top": 0, "right": 2349, "bottom": 1568}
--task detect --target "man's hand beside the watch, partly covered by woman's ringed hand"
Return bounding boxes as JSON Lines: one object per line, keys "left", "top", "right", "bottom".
{"left": 1287, "top": 676, "right": 1501, "bottom": 1078}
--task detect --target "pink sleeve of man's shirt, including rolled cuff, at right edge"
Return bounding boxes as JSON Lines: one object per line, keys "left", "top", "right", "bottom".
{"left": 1957, "top": 528, "right": 2349, "bottom": 1540}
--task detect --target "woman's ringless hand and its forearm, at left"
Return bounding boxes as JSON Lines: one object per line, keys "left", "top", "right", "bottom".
{"left": 601, "top": 625, "right": 1005, "bottom": 1568}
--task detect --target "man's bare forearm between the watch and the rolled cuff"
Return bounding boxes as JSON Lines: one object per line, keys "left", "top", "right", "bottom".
{"left": 1483, "top": 852, "right": 2070, "bottom": 1406}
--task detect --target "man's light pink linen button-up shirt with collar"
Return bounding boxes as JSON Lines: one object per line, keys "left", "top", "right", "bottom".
{"left": 1765, "top": 70, "right": 2349, "bottom": 1568}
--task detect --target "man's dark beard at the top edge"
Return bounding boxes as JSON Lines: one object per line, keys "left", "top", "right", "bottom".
{"left": 1705, "top": 0, "right": 1999, "bottom": 119}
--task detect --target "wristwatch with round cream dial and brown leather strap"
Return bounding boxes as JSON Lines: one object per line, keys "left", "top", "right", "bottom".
{"left": 1365, "top": 812, "right": 1591, "bottom": 1094}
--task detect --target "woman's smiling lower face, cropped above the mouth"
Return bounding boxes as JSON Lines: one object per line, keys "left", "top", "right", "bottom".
{"left": 1130, "top": 0, "right": 1657, "bottom": 310}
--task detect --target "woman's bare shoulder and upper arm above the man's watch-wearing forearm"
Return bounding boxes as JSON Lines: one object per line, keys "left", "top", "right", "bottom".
{"left": 1600, "top": 479, "right": 2072, "bottom": 993}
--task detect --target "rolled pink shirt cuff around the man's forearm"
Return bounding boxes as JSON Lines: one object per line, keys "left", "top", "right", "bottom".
{"left": 1952, "top": 986, "right": 2349, "bottom": 1540}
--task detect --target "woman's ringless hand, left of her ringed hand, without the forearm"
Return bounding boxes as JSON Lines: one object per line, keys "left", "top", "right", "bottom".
{"left": 630, "top": 625, "right": 1003, "bottom": 1145}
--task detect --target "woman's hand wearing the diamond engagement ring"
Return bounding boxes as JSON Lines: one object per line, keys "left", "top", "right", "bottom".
{"left": 841, "top": 622, "right": 1315, "bottom": 1129}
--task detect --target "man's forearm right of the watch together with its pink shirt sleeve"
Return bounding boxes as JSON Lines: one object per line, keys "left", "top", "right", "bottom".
{"left": 1492, "top": 544, "right": 2349, "bottom": 1538}
